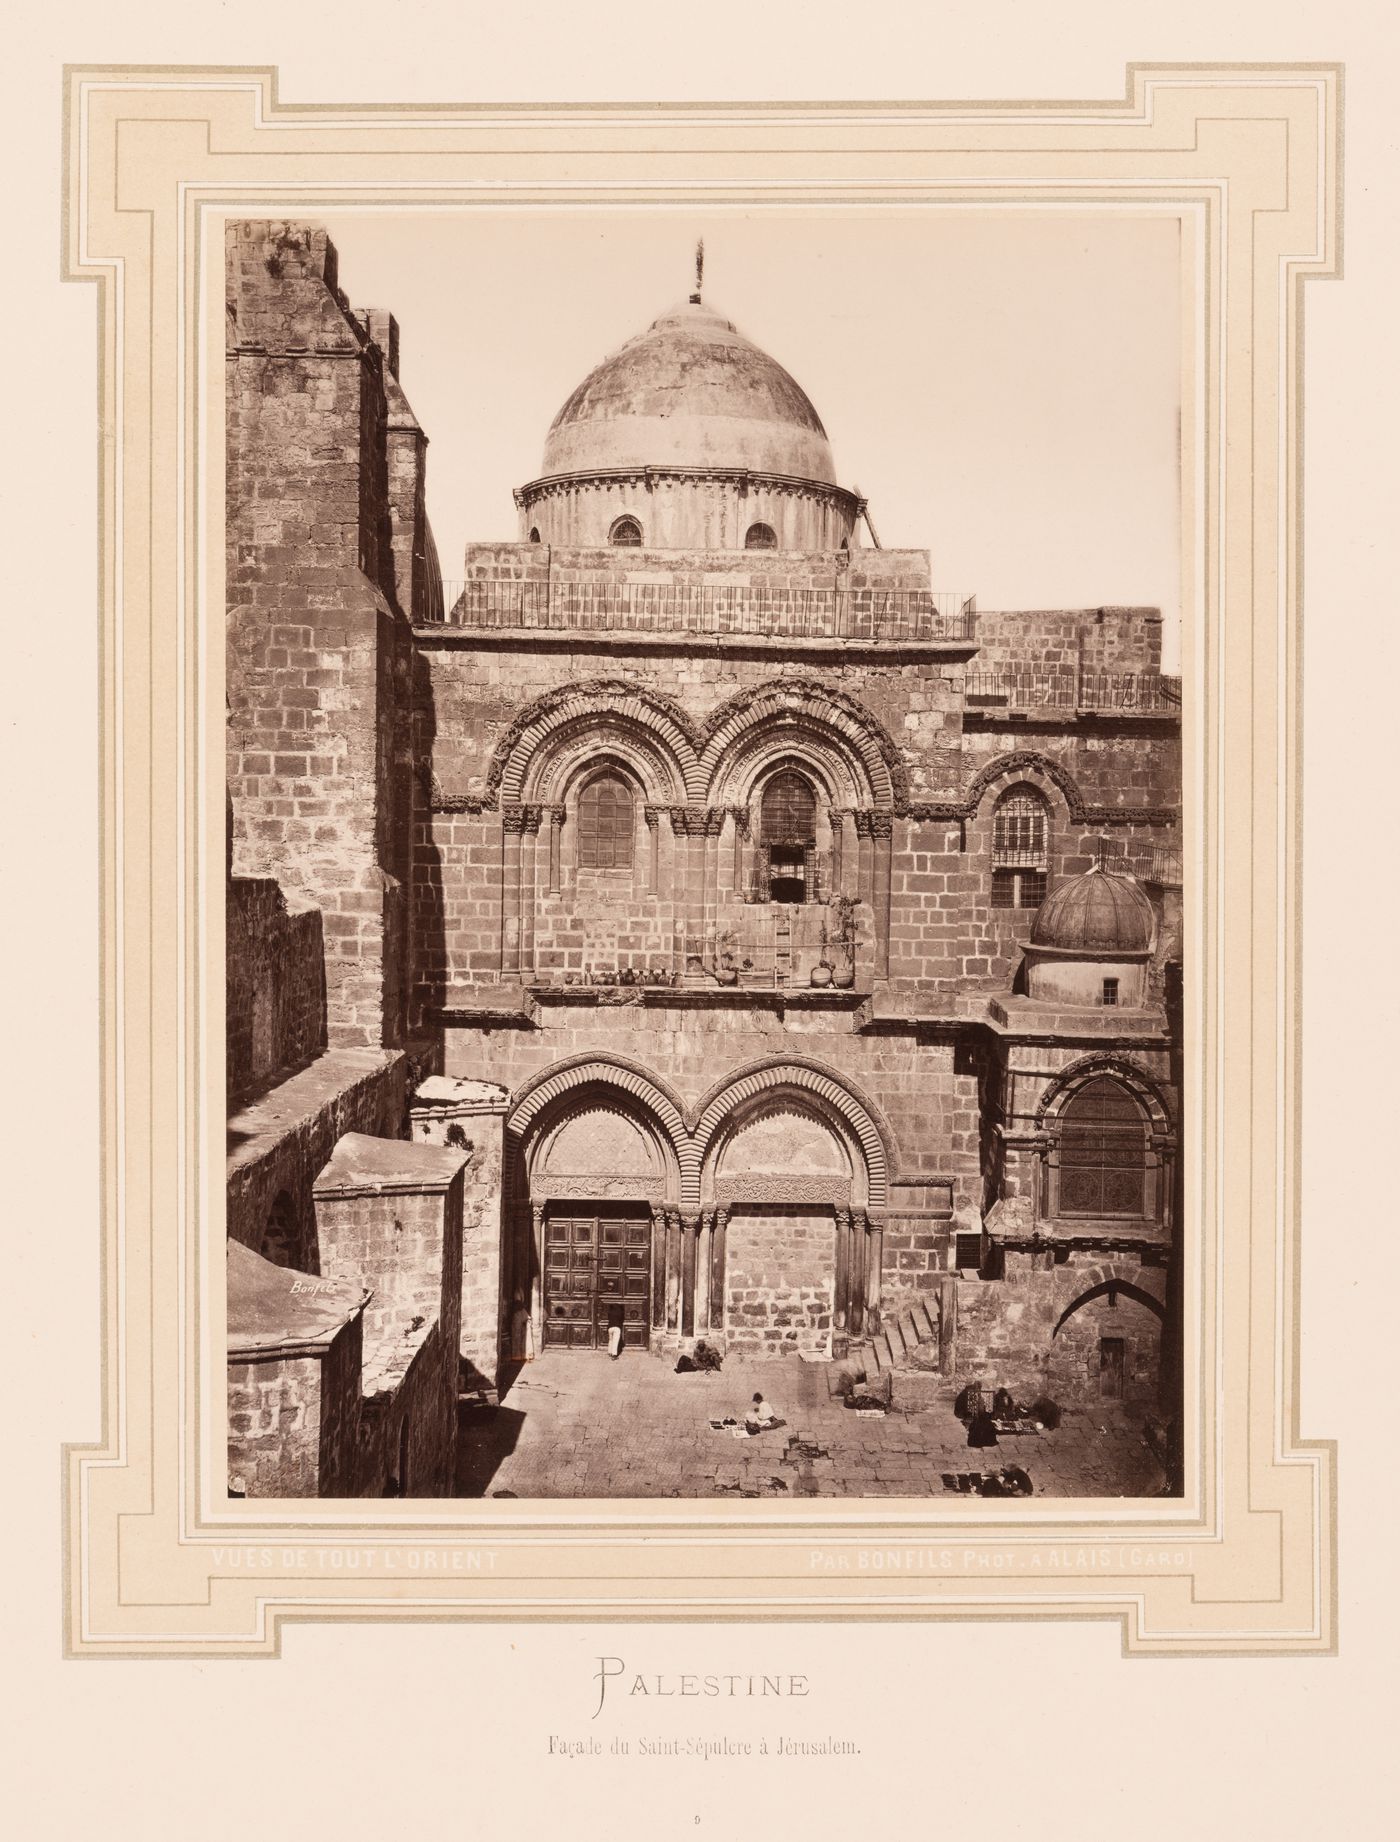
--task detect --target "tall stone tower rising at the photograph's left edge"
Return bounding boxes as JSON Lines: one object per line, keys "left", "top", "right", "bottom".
{"left": 227, "top": 223, "right": 409, "bottom": 1046}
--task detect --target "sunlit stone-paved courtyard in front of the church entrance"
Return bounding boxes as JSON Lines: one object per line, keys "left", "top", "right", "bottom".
{"left": 457, "top": 1350, "right": 1164, "bottom": 1498}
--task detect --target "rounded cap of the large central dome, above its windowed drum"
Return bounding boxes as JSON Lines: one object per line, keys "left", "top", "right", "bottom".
{"left": 543, "top": 300, "right": 836, "bottom": 486}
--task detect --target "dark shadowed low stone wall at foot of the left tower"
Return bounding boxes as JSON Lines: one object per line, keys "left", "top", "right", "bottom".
{"left": 225, "top": 877, "right": 326, "bottom": 1105}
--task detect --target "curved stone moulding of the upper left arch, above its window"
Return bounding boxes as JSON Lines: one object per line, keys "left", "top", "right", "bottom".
{"left": 486, "top": 678, "right": 704, "bottom": 803}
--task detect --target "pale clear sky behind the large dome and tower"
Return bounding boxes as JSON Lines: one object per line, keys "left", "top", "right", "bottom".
{"left": 326, "top": 206, "right": 1181, "bottom": 654}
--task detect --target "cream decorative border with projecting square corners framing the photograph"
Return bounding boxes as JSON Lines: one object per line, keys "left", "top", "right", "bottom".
{"left": 64, "top": 64, "right": 1341, "bottom": 1656}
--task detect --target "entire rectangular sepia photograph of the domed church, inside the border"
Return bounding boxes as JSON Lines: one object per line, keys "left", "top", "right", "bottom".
{"left": 225, "top": 204, "right": 1196, "bottom": 1507}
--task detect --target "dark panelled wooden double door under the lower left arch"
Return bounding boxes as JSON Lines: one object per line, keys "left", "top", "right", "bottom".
{"left": 545, "top": 1203, "right": 652, "bottom": 1350}
